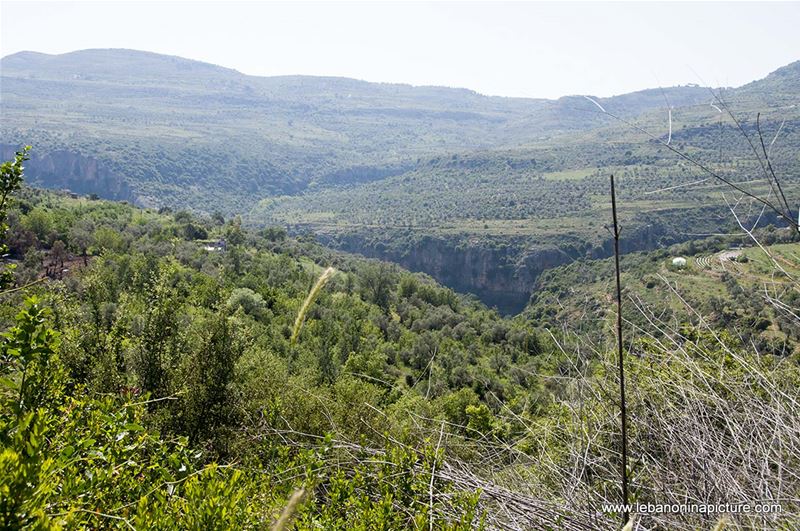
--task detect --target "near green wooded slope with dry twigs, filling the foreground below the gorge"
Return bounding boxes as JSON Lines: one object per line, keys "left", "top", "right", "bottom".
{"left": 0, "top": 152, "right": 800, "bottom": 531}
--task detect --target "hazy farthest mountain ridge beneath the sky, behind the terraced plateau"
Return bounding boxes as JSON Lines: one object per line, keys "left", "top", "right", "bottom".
{"left": 0, "top": 50, "right": 720, "bottom": 211}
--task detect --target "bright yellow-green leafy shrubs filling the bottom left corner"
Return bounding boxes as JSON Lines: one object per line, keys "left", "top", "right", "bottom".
{"left": 0, "top": 299, "right": 256, "bottom": 529}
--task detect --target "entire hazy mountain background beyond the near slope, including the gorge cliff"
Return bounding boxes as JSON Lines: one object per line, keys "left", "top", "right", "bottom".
{"left": 0, "top": 50, "right": 800, "bottom": 311}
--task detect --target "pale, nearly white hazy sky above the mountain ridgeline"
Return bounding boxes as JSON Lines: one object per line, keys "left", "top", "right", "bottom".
{"left": 0, "top": 1, "right": 800, "bottom": 97}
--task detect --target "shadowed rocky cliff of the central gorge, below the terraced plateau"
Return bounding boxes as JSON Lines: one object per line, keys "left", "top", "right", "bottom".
{"left": 318, "top": 209, "right": 732, "bottom": 314}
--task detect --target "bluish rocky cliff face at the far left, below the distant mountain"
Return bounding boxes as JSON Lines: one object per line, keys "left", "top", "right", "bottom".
{"left": 0, "top": 144, "right": 136, "bottom": 202}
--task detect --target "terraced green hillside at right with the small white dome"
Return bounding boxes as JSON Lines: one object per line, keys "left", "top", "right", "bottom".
{"left": 526, "top": 236, "right": 800, "bottom": 355}
